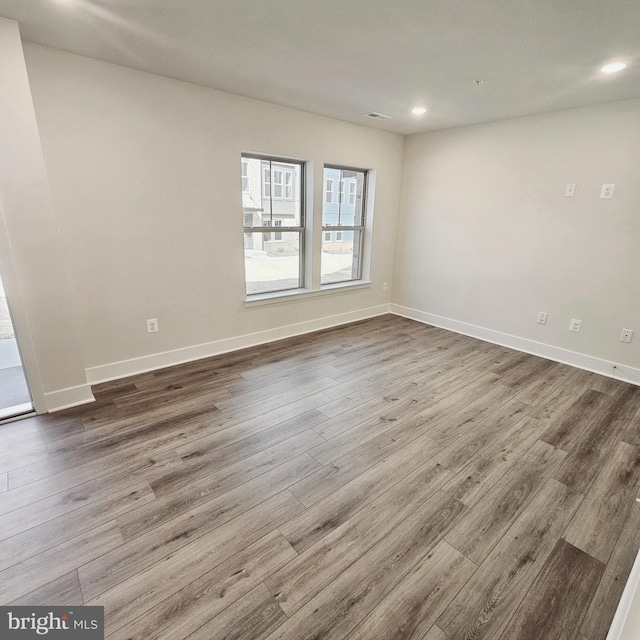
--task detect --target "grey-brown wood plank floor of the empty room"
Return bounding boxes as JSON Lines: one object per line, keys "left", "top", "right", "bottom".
{"left": 0, "top": 316, "right": 640, "bottom": 640}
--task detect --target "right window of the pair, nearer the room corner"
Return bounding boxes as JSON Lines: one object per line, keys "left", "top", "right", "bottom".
{"left": 320, "top": 165, "right": 367, "bottom": 285}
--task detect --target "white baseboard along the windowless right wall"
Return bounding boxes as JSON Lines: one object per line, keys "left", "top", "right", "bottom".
{"left": 390, "top": 304, "right": 640, "bottom": 385}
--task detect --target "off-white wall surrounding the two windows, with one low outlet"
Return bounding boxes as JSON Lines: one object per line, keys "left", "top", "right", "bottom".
{"left": 25, "top": 44, "right": 404, "bottom": 381}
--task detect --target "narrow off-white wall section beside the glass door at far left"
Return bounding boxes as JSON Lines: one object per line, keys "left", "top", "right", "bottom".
{"left": 0, "top": 18, "right": 92, "bottom": 412}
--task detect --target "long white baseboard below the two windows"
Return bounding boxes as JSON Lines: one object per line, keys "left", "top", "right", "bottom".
{"left": 86, "top": 304, "right": 389, "bottom": 384}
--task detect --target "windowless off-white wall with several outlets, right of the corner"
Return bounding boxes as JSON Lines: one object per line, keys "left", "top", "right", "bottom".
{"left": 393, "top": 100, "right": 640, "bottom": 383}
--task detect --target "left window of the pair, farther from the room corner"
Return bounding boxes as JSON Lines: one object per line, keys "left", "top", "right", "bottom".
{"left": 242, "top": 154, "right": 305, "bottom": 296}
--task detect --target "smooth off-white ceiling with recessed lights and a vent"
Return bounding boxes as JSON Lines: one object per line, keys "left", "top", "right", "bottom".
{"left": 0, "top": 0, "right": 640, "bottom": 133}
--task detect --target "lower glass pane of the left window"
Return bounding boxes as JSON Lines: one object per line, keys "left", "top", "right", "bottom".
{"left": 244, "top": 232, "right": 301, "bottom": 295}
